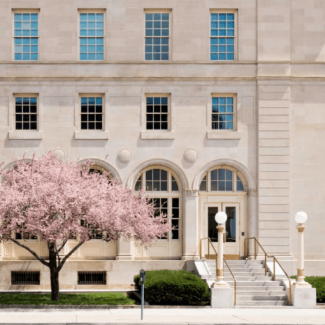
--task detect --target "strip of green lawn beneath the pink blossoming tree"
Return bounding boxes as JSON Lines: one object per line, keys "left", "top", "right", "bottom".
{"left": 0, "top": 292, "right": 136, "bottom": 305}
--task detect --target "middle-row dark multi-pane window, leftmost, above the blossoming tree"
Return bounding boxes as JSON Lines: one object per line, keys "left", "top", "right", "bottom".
{"left": 15, "top": 97, "right": 37, "bottom": 130}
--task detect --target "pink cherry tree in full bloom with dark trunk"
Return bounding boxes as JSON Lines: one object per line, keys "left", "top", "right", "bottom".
{"left": 0, "top": 152, "right": 170, "bottom": 300}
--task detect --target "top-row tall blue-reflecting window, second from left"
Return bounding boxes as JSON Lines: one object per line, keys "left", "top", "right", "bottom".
{"left": 79, "top": 13, "right": 104, "bottom": 61}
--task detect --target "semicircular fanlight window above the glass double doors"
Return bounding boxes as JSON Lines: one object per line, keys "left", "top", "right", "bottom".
{"left": 200, "top": 167, "right": 247, "bottom": 192}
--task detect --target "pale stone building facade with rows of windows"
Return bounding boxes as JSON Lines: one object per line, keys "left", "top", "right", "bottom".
{"left": 0, "top": 0, "right": 325, "bottom": 288}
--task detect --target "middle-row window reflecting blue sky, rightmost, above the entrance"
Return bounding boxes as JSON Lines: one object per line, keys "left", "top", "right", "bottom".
{"left": 211, "top": 97, "right": 234, "bottom": 130}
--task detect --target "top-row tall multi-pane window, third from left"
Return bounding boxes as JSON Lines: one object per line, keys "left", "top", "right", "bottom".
{"left": 145, "top": 12, "right": 170, "bottom": 61}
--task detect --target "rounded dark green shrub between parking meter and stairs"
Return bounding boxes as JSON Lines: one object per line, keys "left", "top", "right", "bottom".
{"left": 134, "top": 270, "right": 211, "bottom": 305}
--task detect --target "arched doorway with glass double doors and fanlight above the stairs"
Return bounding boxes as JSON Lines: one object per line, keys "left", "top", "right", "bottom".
{"left": 199, "top": 165, "right": 247, "bottom": 259}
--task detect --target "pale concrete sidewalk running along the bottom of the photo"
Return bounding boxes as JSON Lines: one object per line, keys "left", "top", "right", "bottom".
{"left": 0, "top": 308, "right": 325, "bottom": 325}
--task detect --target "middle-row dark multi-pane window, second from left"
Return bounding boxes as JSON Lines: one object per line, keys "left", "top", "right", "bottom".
{"left": 81, "top": 97, "right": 103, "bottom": 130}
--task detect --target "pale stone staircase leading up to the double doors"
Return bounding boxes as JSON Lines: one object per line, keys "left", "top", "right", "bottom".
{"left": 205, "top": 260, "right": 288, "bottom": 308}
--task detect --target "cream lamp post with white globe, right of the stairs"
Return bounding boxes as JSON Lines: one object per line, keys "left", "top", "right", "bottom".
{"left": 293, "top": 211, "right": 311, "bottom": 287}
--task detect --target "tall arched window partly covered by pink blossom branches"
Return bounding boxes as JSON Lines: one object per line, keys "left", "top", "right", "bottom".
{"left": 134, "top": 165, "right": 182, "bottom": 259}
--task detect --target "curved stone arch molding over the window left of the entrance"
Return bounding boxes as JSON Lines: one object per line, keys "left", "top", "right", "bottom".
{"left": 126, "top": 158, "right": 190, "bottom": 190}
